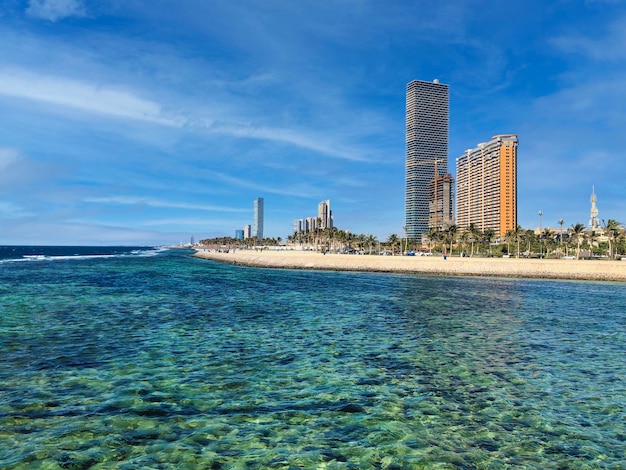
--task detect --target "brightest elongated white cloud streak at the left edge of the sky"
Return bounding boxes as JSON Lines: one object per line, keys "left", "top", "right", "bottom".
{"left": 0, "top": 69, "right": 183, "bottom": 126}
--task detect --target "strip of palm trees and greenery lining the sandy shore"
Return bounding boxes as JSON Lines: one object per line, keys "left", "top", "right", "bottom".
{"left": 200, "top": 219, "right": 626, "bottom": 259}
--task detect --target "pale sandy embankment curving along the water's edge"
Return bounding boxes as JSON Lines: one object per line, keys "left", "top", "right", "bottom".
{"left": 194, "top": 250, "right": 626, "bottom": 282}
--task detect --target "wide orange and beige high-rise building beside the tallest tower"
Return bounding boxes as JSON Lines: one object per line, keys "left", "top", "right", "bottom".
{"left": 456, "top": 134, "right": 518, "bottom": 238}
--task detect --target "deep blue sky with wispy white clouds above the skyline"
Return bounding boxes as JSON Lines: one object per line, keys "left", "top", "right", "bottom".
{"left": 0, "top": 0, "right": 626, "bottom": 244}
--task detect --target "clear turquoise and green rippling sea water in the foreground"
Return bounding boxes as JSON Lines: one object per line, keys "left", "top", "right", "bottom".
{"left": 0, "top": 248, "right": 626, "bottom": 469}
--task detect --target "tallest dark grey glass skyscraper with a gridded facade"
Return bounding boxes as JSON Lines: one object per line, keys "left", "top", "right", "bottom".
{"left": 405, "top": 80, "right": 450, "bottom": 238}
